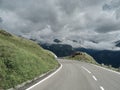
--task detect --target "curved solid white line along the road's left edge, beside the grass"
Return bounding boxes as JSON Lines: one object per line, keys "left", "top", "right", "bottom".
{"left": 26, "top": 64, "right": 63, "bottom": 90}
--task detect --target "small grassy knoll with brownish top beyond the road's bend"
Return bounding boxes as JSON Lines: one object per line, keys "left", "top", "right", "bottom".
{"left": 65, "top": 52, "right": 97, "bottom": 64}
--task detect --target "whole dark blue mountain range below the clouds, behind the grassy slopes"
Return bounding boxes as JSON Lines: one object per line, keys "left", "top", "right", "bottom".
{"left": 41, "top": 44, "right": 120, "bottom": 68}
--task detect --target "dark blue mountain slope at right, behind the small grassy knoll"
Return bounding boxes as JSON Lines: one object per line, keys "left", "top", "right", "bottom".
{"left": 74, "top": 48, "right": 120, "bottom": 68}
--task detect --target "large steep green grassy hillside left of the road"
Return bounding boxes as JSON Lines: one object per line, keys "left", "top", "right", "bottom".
{"left": 0, "top": 30, "right": 58, "bottom": 89}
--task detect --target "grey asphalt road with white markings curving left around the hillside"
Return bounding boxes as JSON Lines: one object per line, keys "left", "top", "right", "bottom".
{"left": 27, "top": 60, "right": 120, "bottom": 90}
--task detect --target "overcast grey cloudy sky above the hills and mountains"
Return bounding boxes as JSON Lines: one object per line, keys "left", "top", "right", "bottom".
{"left": 0, "top": 0, "right": 120, "bottom": 50}
